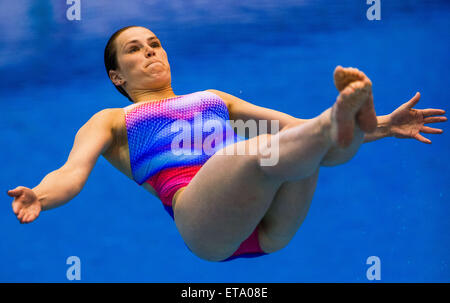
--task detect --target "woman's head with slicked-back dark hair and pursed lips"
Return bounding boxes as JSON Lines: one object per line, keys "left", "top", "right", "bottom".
{"left": 104, "top": 26, "right": 171, "bottom": 102}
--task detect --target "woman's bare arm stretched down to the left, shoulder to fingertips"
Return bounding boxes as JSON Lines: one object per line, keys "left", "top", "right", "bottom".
{"left": 8, "top": 109, "right": 114, "bottom": 223}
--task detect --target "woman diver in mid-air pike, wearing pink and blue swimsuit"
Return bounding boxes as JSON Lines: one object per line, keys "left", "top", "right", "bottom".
{"left": 8, "top": 26, "right": 447, "bottom": 261}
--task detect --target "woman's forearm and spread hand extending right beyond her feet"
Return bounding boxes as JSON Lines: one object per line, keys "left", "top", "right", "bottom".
{"left": 364, "top": 93, "right": 447, "bottom": 144}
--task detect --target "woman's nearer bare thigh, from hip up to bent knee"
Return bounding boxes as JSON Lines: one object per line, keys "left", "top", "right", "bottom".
{"left": 174, "top": 139, "right": 281, "bottom": 260}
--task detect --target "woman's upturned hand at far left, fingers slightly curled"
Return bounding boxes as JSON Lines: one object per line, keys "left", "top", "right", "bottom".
{"left": 7, "top": 186, "right": 42, "bottom": 223}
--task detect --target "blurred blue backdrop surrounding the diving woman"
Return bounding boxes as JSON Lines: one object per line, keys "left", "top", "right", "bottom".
{"left": 0, "top": 0, "right": 450, "bottom": 282}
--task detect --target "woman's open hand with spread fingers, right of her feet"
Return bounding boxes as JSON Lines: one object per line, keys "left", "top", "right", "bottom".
{"left": 389, "top": 93, "right": 447, "bottom": 144}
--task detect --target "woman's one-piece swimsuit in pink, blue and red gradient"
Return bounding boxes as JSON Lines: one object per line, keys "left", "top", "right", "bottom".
{"left": 124, "top": 91, "right": 264, "bottom": 260}
